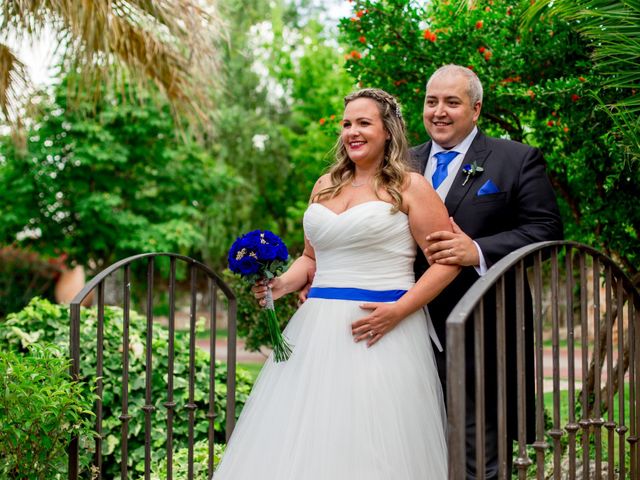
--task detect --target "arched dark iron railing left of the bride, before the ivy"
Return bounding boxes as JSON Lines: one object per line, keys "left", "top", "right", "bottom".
{"left": 69, "top": 253, "right": 237, "bottom": 480}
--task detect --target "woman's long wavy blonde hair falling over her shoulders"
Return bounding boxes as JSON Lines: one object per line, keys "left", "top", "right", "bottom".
{"left": 312, "top": 88, "right": 409, "bottom": 211}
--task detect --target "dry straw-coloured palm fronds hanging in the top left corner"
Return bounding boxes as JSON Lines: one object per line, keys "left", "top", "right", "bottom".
{"left": 0, "top": 0, "right": 224, "bottom": 133}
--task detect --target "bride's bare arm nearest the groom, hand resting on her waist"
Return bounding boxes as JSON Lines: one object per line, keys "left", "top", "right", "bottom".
{"left": 352, "top": 173, "right": 460, "bottom": 345}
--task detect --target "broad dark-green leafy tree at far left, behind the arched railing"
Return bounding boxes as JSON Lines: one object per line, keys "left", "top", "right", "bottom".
{"left": 0, "top": 82, "right": 237, "bottom": 268}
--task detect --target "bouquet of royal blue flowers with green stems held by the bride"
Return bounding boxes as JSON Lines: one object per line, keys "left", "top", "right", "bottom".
{"left": 229, "top": 230, "right": 291, "bottom": 362}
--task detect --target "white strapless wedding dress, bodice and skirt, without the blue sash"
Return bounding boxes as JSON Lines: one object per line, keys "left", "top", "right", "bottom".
{"left": 213, "top": 201, "right": 447, "bottom": 480}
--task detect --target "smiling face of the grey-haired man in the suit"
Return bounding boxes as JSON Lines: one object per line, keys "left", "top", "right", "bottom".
{"left": 423, "top": 73, "right": 482, "bottom": 149}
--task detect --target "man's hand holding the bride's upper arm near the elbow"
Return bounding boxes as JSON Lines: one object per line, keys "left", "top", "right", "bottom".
{"left": 424, "top": 217, "right": 480, "bottom": 266}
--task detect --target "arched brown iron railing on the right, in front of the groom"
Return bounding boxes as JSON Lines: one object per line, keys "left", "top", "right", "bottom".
{"left": 447, "top": 241, "right": 640, "bottom": 480}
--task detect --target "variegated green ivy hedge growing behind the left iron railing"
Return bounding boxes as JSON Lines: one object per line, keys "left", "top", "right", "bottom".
{"left": 0, "top": 298, "right": 251, "bottom": 476}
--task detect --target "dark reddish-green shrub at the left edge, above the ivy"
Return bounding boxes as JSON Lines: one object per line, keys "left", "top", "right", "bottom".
{"left": 0, "top": 247, "right": 60, "bottom": 319}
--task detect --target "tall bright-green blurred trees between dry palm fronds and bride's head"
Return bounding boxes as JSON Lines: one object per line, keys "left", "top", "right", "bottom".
{"left": 205, "top": 0, "right": 352, "bottom": 258}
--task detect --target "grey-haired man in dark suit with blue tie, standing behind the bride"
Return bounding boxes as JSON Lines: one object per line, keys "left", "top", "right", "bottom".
{"left": 412, "top": 65, "right": 562, "bottom": 479}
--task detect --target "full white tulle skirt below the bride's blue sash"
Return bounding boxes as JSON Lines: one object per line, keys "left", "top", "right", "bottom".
{"left": 213, "top": 298, "right": 447, "bottom": 480}
